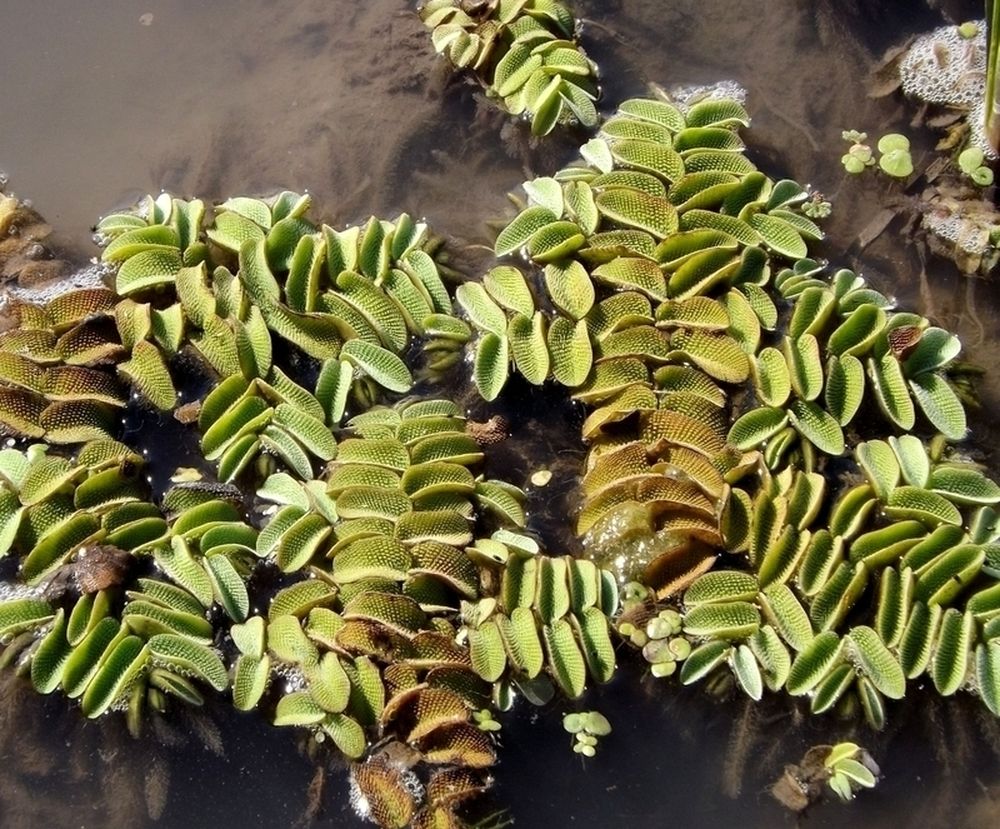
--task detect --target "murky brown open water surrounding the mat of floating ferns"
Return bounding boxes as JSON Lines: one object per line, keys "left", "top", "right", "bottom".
{"left": 0, "top": 0, "right": 1000, "bottom": 829}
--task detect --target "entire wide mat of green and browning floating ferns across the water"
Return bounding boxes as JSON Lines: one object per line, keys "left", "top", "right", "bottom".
{"left": 0, "top": 76, "right": 1000, "bottom": 826}
